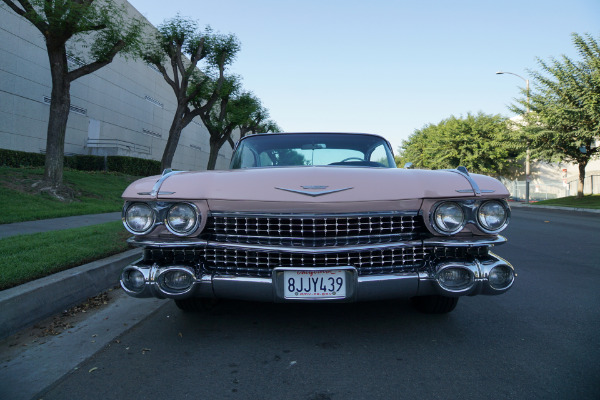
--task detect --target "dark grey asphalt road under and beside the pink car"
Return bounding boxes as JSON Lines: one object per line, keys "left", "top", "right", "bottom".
{"left": 34, "top": 209, "right": 600, "bottom": 400}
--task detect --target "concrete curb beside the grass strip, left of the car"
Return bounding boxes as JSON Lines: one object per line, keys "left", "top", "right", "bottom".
{"left": 0, "top": 249, "right": 142, "bottom": 339}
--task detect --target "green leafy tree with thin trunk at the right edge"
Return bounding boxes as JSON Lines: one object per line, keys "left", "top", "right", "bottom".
{"left": 511, "top": 33, "right": 600, "bottom": 198}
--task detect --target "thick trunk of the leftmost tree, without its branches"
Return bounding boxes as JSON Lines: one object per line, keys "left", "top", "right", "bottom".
{"left": 44, "top": 42, "right": 71, "bottom": 189}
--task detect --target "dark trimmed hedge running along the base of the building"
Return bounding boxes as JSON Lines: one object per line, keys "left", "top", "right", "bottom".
{"left": 0, "top": 149, "right": 161, "bottom": 176}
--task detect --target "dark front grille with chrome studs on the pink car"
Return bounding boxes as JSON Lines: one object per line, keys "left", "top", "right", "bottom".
{"left": 144, "top": 211, "right": 487, "bottom": 277}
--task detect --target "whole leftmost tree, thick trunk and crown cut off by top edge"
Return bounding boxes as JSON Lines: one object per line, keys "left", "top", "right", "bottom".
{"left": 2, "top": 0, "right": 142, "bottom": 198}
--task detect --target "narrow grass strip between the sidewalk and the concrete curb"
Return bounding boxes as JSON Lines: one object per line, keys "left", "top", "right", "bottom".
{"left": 0, "top": 221, "right": 131, "bottom": 290}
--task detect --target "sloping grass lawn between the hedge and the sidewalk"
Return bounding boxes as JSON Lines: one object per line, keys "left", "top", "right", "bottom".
{"left": 0, "top": 167, "right": 137, "bottom": 224}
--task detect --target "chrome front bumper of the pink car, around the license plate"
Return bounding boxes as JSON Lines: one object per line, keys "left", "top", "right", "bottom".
{"left": 121, "top": 253, "right": 515, "bottom": 302}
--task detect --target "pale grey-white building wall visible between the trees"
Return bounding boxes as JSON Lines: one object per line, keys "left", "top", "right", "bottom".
{"left": 0, "top": 3, "right": 236, "bottom": 170}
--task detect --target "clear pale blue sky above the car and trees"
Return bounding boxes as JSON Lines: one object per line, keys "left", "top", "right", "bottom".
{"left": 129, "top": 0, "right": 600, "bottom": 152}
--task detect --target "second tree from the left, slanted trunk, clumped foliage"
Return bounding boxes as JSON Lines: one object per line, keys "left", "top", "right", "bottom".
{"left": 142, "top": 15, "right": 240, "bottom": 169}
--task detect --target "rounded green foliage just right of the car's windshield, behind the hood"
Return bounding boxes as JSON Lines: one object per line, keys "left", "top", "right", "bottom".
{"left": 396, "top": 113, "right": 516, "bottom": 176}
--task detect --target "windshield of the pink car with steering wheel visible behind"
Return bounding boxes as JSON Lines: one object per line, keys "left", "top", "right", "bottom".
{"left": 231, "top": 133, "right": 396, "bottom": 169}
